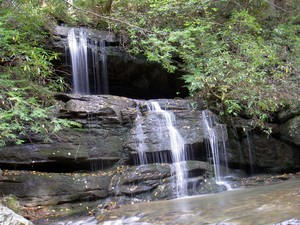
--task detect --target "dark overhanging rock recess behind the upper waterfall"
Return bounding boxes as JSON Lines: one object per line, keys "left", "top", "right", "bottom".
{"left": 52, "top": 26, "right": 188, "bottom": 99}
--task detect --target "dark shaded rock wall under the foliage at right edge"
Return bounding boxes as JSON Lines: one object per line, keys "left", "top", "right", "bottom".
{"left": 229, "top": 101, "right": 300, "bottom": 173}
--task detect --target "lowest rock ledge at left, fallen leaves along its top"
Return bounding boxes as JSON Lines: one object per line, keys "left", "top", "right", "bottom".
{"left": 0, "top": 171, "right": 113, "bottom": 206}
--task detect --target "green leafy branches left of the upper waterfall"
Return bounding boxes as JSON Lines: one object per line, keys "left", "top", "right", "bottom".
{"left": 0, "top": 2, "right": 79, "bottom": 146}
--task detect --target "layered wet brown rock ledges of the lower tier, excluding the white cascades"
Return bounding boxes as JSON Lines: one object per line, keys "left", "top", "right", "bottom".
{"left": 0, "top": 94, "right": 300, "bottom": 221}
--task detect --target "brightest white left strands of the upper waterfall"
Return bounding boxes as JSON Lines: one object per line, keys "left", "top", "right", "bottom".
{"left": 68, "top": 29, "right": 90, "bottom": 94}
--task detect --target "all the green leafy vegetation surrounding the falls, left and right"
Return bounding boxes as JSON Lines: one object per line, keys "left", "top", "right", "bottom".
{"left": 0, "top": 0, "right": 300, "bottom": 145}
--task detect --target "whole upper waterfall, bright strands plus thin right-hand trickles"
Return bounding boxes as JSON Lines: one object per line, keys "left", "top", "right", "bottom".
{"left": 68, "top": 28, "right": 109, "bottom": 94}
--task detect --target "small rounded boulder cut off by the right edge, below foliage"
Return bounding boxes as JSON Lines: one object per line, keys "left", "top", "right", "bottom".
{"left": 280, "top": 116, "right": 300, "bottom": 146}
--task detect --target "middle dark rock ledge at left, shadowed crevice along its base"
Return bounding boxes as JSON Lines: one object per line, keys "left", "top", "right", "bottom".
{"left": 0, "top": 127, "right": 127, "bottom": 172}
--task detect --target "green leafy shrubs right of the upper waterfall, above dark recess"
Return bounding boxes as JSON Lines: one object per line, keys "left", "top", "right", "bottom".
{"left": 111, "top": 0, "right": 300, "bottom": 129}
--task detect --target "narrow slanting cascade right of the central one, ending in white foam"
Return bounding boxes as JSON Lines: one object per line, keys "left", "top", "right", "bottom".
{"left": 202, "top": 110, "right": 231, "bottom": 189}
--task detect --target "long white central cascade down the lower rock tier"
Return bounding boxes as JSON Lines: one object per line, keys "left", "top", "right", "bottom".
{"left": 149, "top": 102, "right": 188, "bottom": 197}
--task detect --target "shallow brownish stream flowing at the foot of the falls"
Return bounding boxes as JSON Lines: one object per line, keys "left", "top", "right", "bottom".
{"left": 100, "top": 179, "right": 300, "bottom": 225}
